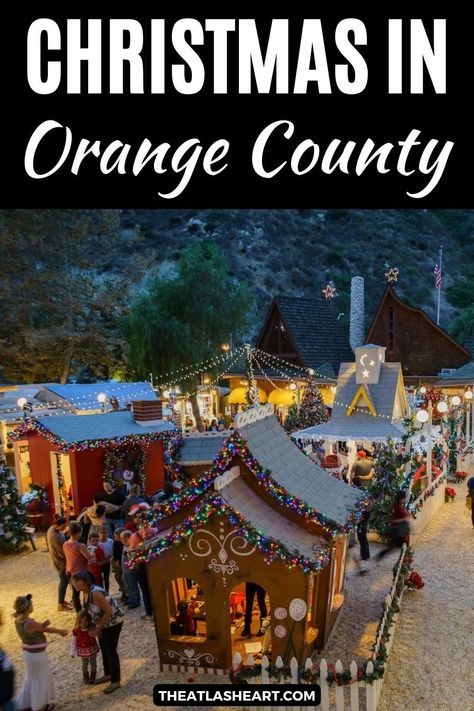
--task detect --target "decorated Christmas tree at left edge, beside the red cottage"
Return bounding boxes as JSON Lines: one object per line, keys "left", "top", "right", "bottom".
{"left": 0, "top": 464, "right": 28, "bottom": 553}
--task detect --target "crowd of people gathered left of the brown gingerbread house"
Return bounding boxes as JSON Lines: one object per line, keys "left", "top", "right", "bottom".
{"left": 6, "top": 482, "right": 157, "bottom": 711}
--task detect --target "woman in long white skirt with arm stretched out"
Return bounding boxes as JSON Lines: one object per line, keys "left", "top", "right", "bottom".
{"left": 13, "top": 594, "right": 68, "bottom": 711}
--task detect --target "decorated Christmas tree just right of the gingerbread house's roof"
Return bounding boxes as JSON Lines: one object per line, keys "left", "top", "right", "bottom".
{"left": 368, "top": 440, "right": 407, "bottom": 536}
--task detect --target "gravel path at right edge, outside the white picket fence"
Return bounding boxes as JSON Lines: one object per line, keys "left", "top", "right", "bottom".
{"left": 378, "top": 484, "right": 474, "bottom": 711}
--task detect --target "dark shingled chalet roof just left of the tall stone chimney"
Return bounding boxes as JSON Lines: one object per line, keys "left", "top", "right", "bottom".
{"left": 257, "top": 296, "right": 353, "bottom": 377}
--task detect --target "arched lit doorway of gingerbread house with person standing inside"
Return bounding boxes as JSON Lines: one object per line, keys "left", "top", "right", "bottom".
{"left": 229, "top": 581, "right": 271, "bottom": 663}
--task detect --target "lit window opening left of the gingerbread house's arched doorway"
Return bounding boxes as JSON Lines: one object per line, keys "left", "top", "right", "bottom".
{"left": 168, "top": 578, "right": 207, "bottom": 640}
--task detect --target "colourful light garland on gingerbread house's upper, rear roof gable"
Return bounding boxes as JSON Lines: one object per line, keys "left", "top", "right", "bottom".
{"left": 147, "top": 431, "right": 368, "bottom": 539}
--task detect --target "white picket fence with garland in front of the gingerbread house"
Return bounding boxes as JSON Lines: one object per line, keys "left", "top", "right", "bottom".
{"left": 233, "top": 545, "right": 406, "bottom": 711}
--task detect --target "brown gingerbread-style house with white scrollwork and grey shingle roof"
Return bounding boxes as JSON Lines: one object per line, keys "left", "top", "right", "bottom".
{"left": 130, "top": 405, "right": 365, "bottom": 673}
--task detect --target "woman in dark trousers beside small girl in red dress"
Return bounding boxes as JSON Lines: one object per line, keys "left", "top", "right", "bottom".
{"left": 72, "top": 572, "right": 123, "bottom": 694}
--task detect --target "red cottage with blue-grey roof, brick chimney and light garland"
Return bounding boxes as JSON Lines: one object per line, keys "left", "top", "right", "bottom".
{"left": 10, "top": 400, "right": 180, "bottom": 523}
